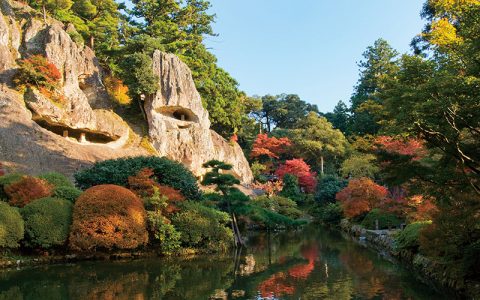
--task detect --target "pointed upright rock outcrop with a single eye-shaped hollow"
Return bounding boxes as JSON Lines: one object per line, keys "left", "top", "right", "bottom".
{"left": 145, "top": 51, "right": 253, "bottom": 183}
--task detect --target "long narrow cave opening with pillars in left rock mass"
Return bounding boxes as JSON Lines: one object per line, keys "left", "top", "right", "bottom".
{"left": 34, "top": 120, "right": 117, "bottom": 144}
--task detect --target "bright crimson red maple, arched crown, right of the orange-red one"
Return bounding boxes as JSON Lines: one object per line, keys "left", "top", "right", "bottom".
{"left": 275, "top": 158, "right": 317, "bottom": 193}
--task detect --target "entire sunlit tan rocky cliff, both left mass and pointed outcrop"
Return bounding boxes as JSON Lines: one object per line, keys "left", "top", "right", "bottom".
{"left": 0, "top": 0, "right": 252, "bottom": 183}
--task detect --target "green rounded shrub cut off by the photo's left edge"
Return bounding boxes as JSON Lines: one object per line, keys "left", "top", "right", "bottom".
{"left": 0, "top": 201, "right": 24, "bottom": 248}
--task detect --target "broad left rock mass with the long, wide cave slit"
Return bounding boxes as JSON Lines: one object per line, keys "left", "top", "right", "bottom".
{"left": 0, "top": 0, "right": 142, "bottom": 175}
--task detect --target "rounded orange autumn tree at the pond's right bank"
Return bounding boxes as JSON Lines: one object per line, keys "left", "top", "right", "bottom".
{"left": 335, "top": 178, "right": 388, "bottom": 218}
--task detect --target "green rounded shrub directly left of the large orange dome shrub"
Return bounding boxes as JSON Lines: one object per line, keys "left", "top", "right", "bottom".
{"left": 20, "top": 197, "right": 73, "bottom": 249}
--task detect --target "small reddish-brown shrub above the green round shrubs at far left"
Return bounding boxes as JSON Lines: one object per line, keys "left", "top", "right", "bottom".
{"left": 4, "top": 176, "right": 54, "bottom": 207}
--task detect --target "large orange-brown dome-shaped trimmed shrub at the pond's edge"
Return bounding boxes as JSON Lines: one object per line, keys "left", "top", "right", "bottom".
{"left": 70, "top": 184, "right": 148, "bottom": 250}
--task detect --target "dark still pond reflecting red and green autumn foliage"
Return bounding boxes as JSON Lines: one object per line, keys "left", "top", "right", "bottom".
{"left": 0, "top": 226, "right": 452, "bottom": 300}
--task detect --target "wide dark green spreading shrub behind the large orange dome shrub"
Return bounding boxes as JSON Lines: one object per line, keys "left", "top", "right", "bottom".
{"left": 75, "top": 156, "right": 201, "bottom": 200}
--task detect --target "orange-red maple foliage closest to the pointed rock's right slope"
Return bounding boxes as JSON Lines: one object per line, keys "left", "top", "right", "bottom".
{"left": 250, "top": 133, "right": 292, "bottom": 158}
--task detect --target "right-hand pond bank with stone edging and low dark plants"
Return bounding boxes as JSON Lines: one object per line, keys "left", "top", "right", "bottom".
{"left": 340, "top": 220, "right": 480, "bottom": 299}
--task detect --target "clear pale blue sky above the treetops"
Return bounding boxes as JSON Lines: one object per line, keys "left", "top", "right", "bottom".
{"left": 202, "top": 0, "right": 424, "bottom": 112}
